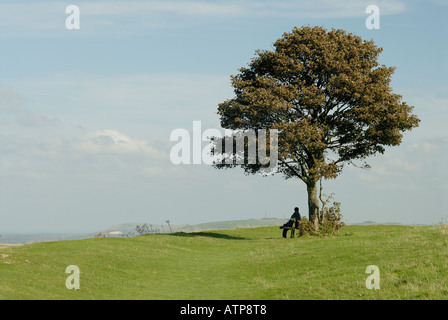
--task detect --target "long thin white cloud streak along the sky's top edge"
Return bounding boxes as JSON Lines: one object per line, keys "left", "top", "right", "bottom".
{"left": 0, "top": 0, "right": 406, "bottom": 37}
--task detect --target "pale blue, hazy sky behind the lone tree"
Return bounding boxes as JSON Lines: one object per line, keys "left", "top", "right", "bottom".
{"left": 0, "top": 0, "right": 448, "bottom": 233}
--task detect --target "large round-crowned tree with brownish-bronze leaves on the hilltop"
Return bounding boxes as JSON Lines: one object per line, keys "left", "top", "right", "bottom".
{"left": 214, "top": 26, "right": 420, "bottom": 220}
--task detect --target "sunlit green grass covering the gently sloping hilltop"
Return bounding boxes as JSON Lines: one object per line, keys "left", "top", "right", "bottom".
{"left": 0, "top": 225, "right": 448, "bottom": 300}
